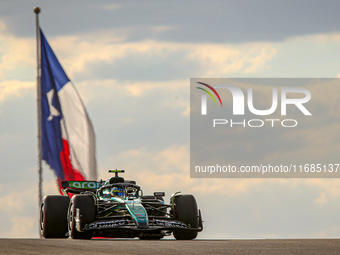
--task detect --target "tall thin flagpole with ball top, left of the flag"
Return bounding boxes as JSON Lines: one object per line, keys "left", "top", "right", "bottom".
{"left": 33, "top": 7, "right": 42, "bottom": 238}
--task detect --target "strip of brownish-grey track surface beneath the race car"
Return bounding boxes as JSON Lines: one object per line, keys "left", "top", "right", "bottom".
{"left": 0, "top": 238, "right": 340, "bottom": 255}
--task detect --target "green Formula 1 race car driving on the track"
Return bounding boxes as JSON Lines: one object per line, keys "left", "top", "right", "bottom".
{"left": 40, "top": 170, "right": 203, "bottom": 240}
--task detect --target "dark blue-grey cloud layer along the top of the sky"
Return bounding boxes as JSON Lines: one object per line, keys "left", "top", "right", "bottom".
{"left": 0, "top": 0, "right": 339, "bottom": 43}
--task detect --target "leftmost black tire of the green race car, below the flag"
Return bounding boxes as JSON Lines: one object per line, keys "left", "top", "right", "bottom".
{"left": 40, "top": 195, "right": 70, "bottom": 238}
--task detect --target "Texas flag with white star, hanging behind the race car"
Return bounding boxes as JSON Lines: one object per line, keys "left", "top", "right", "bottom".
{"left": 40, "top": 29, "right": 97, "bottom": 189}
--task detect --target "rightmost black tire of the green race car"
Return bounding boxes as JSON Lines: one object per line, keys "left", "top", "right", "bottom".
{"left": 173, "top": 195, "right": 199, "bottom": 240}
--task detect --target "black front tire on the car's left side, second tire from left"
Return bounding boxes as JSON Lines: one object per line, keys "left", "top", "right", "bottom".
{"left": 67, "top": 195, "right": 96, "bottom": 239}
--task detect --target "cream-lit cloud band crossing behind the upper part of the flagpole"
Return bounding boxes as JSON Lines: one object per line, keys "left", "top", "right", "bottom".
{"left": 0, "top": 23, "right": 276, "bottom": 86}
